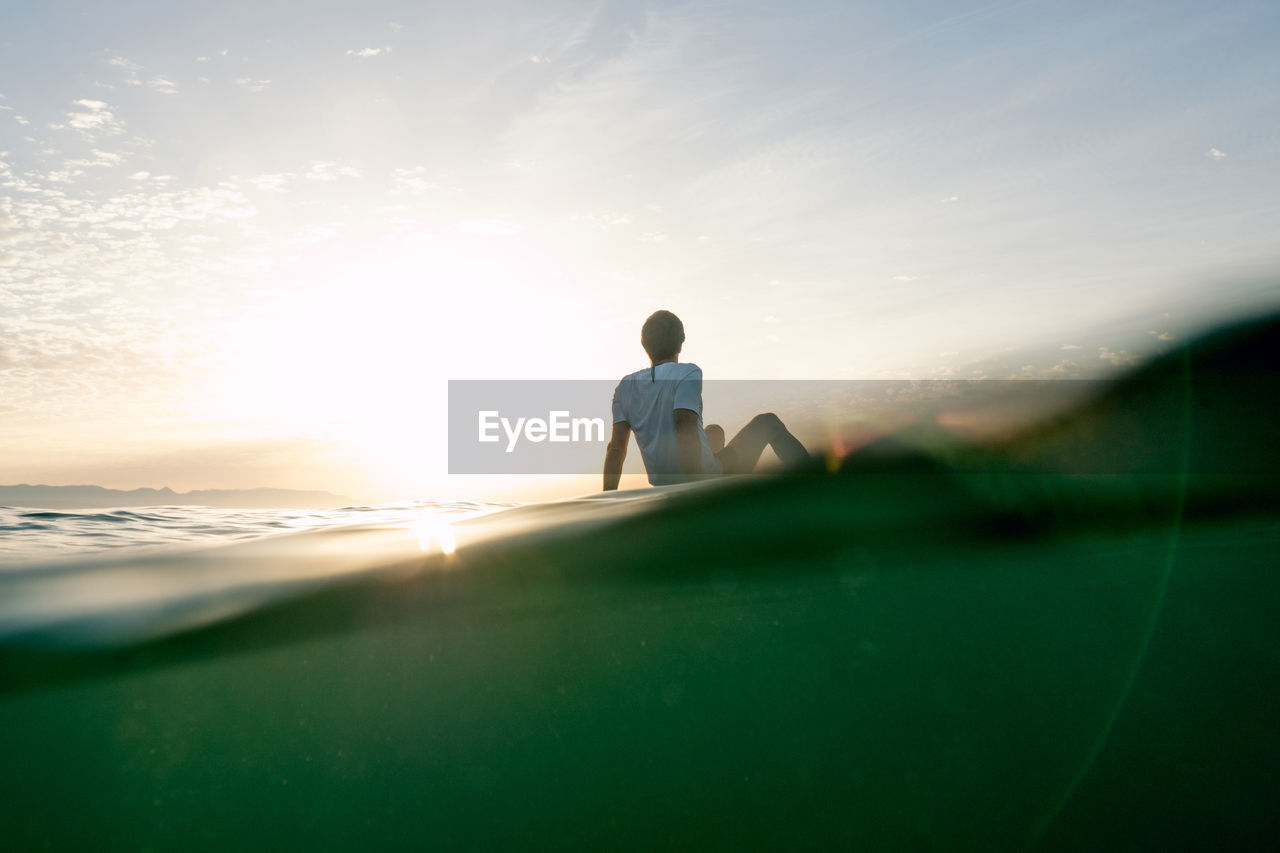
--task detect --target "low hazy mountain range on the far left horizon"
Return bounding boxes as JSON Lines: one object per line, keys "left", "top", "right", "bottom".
{"left": 0, "top": 484, "right": 355, "bottom": 510}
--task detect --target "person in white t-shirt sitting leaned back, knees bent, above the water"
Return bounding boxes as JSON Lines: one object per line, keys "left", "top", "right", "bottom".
{"left": 604, "top": 311, "right": 809, "bottom": 491}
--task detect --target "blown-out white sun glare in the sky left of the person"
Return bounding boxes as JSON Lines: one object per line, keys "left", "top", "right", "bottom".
{"left": 186, "top": 223, "right": 601, "bottom": 494}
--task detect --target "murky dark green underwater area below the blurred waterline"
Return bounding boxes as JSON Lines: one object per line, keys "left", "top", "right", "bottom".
{"left": 0, "top": 484, "right": 1280, "bottom": 849}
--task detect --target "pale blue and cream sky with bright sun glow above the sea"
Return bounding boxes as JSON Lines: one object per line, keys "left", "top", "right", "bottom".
{"left": 0, "top": 0, "right": 1280, "bottom": 501}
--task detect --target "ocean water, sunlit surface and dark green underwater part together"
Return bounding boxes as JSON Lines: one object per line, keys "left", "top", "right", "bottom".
{"left": 0, "top": 315, "right": 1280, "bottom": 850}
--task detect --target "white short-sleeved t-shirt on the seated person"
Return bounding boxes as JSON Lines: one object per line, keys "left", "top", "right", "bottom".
{"left": 613, "top": 361, "right": 721, "bottom": 485}
